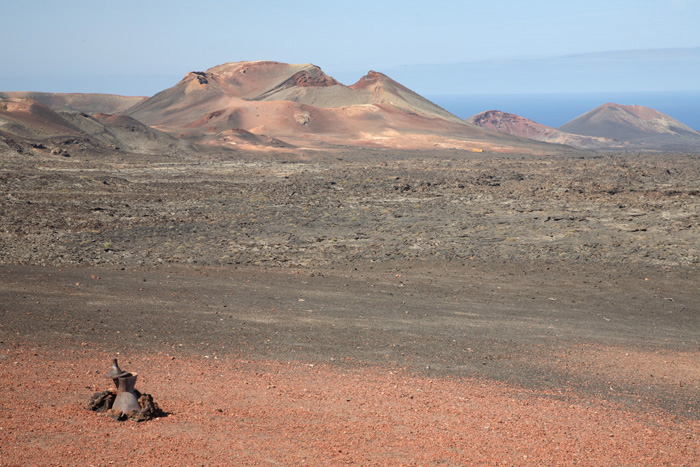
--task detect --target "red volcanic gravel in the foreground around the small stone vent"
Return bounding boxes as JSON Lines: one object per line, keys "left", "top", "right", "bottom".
{"left": 0, "top": 343, "right": 700, "bottom": 466}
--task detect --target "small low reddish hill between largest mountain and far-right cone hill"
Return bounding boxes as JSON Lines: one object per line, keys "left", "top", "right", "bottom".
{"left": 465, "top": 110, "right": 623, "bottom": 149}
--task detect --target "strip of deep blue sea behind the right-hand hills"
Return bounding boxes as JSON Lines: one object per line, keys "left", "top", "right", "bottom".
{"left": 427, "top": 91, "right": 700, "bottom": 131}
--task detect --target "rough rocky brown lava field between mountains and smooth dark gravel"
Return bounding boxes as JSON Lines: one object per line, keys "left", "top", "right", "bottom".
{"left": 0, "top": 150, "right": 700, "bottom": 268}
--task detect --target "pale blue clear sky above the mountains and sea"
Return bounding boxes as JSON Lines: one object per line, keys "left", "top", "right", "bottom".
{"left": 0, "top": 0, "right": 700, "bottom": 95}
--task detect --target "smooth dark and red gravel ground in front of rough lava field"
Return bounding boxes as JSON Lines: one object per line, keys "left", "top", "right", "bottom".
{"left": 0, "top": 263, "right": 700, "bottom": 466}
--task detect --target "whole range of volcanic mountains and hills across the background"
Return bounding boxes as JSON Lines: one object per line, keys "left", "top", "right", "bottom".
{"left": 8, "top": 60, "right": 700, "bottom": 154}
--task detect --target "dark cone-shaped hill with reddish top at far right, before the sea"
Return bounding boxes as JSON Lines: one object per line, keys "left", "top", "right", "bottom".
{"left": 558, "top": 103, "right": 700, "bottom": 151}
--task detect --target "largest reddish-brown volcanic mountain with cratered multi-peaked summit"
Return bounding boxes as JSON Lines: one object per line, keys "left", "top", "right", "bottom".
{"left": 126, "top": 61, "right": 561, "bottom": 153}
